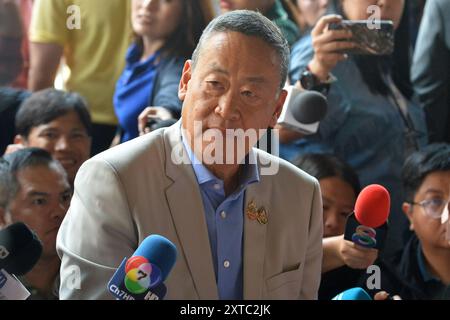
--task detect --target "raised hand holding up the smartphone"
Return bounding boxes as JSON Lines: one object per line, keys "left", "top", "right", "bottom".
{"left": 309, "top": 15, "right": 355, "bottom": 81}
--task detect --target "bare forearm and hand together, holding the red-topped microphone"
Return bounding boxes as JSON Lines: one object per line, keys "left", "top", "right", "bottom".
{"left": 322, "top": 235, "right": 378, "bottom": 273}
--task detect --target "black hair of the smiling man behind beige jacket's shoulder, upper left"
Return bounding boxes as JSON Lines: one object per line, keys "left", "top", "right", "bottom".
{"left": 16, "top": 89, "right": 92, "bottom": 139}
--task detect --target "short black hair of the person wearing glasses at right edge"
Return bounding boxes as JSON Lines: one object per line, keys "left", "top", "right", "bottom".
{"left": 402, "top": 143, "right": 450, "bottom": 202}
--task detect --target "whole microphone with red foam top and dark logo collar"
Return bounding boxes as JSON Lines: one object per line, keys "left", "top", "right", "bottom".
{"left": 344, "top": 184, "right": 391, "bottom": 250}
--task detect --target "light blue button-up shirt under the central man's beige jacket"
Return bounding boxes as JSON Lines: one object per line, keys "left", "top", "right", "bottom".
{"left": 183, "top": 131, "right": 259, "bottom": 300}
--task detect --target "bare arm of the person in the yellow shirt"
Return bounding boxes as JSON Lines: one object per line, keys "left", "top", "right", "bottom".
{"left": 28, "top": 42, "right": 63, "bottom": 91}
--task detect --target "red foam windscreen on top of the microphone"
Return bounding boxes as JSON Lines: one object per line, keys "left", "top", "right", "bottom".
{"left": 355, "top": 184, "right": 391, "bottom": 228}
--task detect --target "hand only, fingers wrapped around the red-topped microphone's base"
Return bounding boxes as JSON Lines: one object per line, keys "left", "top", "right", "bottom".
{"left": 339, "top": 235, "right": 378, "bottom": 269}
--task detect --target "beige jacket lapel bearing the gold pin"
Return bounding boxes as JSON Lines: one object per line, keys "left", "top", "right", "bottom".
{"left": 244, "top": 165, "right": 270, "bottom": 300}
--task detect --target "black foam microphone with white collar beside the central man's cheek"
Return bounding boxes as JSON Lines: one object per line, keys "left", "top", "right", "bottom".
{"left": 278, "top": 86, "right": 328, "bottom": 135}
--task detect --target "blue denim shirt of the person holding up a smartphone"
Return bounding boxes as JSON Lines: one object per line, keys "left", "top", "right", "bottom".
{"left": 286, "top": 35, "right": 427, "bottom": 256}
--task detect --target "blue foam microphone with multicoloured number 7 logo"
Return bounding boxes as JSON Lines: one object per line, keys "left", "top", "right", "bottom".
{"left": 108, "top": 235, "right": 177, "bottom": 300}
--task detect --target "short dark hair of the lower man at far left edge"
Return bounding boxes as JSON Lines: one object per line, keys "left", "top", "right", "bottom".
{"left": 0, "top": 148, "right": 66, "bottom": 208}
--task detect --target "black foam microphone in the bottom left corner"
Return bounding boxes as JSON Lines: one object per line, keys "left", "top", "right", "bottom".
{"left": 0, "top": 222, "right": 42, "bottom": 300}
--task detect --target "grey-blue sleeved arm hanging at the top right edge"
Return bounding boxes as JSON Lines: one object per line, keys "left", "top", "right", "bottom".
{"left": 411, "top": 1, "right": 450, "bottom": 141}
